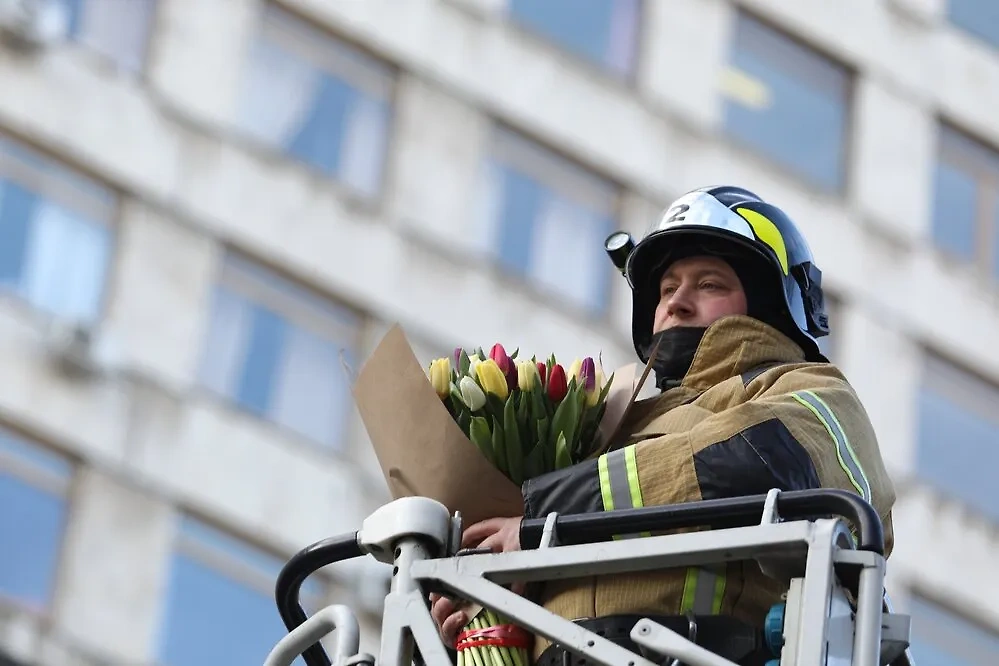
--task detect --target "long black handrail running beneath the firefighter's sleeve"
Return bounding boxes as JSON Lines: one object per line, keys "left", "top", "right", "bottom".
{"left": 520, "top": 488, "right": 885, "bottom": 555}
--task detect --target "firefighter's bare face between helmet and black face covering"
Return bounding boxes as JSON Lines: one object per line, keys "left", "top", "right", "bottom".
{"left": 652, "top": 256, "right": 746, "bottom": 333}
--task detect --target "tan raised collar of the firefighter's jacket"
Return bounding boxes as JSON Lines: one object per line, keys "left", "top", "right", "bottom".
{"left": 680, "top": 315, "right": 805, "bottom": 391}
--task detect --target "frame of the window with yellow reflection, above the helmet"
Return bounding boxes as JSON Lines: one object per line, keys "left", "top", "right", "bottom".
{"left": 718, "top": 6, "right": 858, "bottom": 193}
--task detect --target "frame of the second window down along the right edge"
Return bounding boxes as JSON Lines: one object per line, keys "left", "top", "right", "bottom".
{"left": 929, "top": 118, "right": 999, "bottom": 274}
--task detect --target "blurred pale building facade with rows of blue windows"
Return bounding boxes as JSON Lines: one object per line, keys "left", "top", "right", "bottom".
{"left": 0, "top": 0, "right": 999, "bottom": 666}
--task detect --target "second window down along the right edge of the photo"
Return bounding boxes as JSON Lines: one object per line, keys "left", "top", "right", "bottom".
{"left": 932, "top": 125, "right": 999, "bottom": 279}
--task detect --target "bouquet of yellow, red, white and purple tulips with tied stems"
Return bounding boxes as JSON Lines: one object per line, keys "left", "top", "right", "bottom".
{"left": 428, "top": 344, "right": 613, "bottom": 666}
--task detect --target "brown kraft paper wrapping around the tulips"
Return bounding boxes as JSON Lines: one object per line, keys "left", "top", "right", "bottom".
{"left": 353, "top": 324, "right": 636, "bottom": 526}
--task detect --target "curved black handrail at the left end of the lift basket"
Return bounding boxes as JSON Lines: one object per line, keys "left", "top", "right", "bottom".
{"left": 274, "top": 532, "right": 364, "bottom": 666}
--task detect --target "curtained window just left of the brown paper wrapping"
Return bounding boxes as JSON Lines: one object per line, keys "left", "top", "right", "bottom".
{"left": 201, "top": 255, "right": 361, "bottom": 448}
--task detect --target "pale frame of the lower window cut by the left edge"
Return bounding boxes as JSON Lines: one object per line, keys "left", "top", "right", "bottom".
{"left": 0, "top": 423, "right": 78, "bottom": 618}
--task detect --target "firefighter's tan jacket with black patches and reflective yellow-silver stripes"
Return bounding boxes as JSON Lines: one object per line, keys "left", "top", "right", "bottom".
{"left": 523, "top": 316, "right": 895, "bottom": 656}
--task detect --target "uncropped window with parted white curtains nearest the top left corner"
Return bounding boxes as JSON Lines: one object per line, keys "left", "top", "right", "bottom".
{"left": 237, "top": 7, "right": 394, "bottom": 197}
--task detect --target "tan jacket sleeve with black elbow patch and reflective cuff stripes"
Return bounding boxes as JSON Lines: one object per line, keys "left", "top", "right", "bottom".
{"left": 523, "top": 365, "right": 894, "bottom": 547}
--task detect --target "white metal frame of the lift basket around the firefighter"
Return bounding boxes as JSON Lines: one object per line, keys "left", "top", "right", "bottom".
{"left": 265, "top": 496, "right": 912, "bottom": 666}
